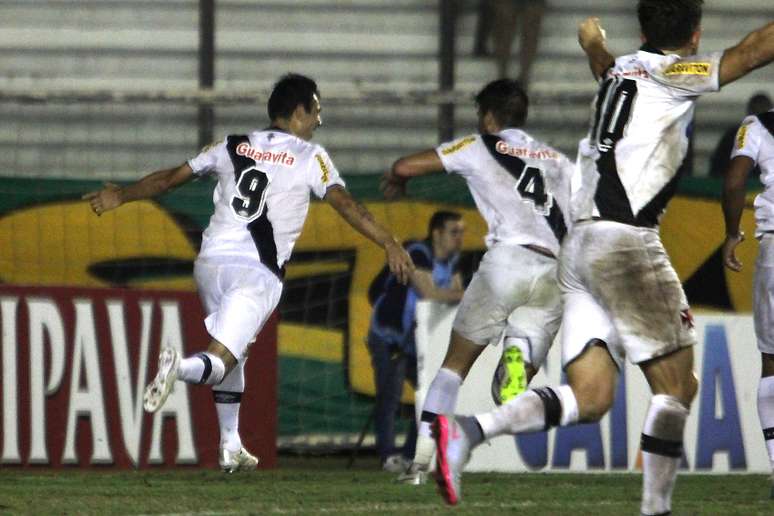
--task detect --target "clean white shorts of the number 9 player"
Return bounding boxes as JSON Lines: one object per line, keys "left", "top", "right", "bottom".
{"left": 194, "top": 259, "right": 282, "bottom": 362}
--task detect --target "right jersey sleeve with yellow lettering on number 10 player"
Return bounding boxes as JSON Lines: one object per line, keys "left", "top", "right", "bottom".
{"left": 655, "top": 52, "right": 723, "bottom": 97}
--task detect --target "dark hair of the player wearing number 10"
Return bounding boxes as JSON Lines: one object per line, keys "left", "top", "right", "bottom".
{"left": 637, "top": 0, "right": 704, "bottom": 49}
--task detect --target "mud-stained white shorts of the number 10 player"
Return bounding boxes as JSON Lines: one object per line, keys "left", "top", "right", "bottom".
{"left": 559, "top": 221, "right": 696, "bottom": 368}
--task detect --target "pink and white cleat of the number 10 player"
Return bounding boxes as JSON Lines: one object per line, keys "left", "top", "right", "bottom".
{"left": 432, "top": 416, "right": 470, "bottom": 505}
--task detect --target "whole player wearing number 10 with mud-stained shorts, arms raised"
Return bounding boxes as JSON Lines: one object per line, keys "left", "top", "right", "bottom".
{"left": 436, "top": 0, "right": 774, "bottom": 515}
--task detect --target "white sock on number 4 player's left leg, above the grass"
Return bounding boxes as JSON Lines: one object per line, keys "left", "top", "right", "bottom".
{"left": 414, "top": 367, "right": 462, "bottom": 466}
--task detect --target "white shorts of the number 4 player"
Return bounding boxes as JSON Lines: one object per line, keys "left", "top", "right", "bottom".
{"left": 453, "top": 245, "right": 562, "bottom": 368}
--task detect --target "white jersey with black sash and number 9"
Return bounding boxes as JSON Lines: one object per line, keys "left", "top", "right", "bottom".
{"left": 188, "top": 129, "right": 344, "bottom": 275}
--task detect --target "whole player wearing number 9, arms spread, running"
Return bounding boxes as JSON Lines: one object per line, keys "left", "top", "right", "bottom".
{"left": 84, "top": 74, "right": 413, "bottom": 472}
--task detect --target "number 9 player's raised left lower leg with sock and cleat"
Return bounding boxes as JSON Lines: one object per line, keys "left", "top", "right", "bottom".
{"left": 143, "top": 339, "right": 237, "bottom": 412}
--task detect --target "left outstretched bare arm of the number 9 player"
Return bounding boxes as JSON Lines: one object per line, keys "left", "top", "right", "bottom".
{"left": 81, "top": 163, "right": 193, "bottom": 215}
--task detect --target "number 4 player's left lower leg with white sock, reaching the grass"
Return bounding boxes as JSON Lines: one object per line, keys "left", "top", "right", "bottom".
{"left": 401, "top": 330, "right": 485, "bottom": 483}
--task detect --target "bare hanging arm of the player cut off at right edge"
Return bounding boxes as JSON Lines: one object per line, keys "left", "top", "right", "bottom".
{"left": 722, "top": 156, "right": 754, "bottom": 272}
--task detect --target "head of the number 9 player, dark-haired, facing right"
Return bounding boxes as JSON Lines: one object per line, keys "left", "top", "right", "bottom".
{"left": 268, "top": 73, "right": 322, "bottom": 140}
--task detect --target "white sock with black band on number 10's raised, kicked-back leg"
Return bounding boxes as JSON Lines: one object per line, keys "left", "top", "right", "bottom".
{"left": 476, "top": 385, "right": 578, "bottom": 439}
